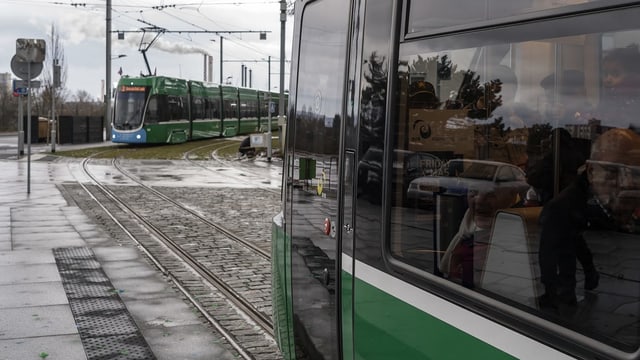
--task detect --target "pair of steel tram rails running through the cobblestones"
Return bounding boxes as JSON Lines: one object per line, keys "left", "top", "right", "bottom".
{"left": 69, "top": 158, "right": 273, "bottom": 359}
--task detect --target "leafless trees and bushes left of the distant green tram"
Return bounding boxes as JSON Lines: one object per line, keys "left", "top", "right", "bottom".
{"left": 0, "top": 24, "right": 105, "bottom": 132}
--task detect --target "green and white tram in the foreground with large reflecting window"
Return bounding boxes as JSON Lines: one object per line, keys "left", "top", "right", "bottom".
{"left": 272, "top": 0, "right": 640, "bottom": 359}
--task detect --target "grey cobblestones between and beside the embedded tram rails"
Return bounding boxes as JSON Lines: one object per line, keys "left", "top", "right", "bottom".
{"left": 60, "top": 158, "right": 281, "bottom": 360}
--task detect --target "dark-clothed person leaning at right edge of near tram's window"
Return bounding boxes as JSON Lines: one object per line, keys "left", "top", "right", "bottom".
{"left": 537, "top": 129, "right": 640, "bottom": 308}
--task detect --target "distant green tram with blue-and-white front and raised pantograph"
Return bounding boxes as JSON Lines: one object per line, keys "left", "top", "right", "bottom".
{"left": 111, "top": 76, "right": 286, "bottom": 144}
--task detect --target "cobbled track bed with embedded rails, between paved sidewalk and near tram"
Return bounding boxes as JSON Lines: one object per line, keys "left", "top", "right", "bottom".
{"left": 63, "top": 158, "right": 279, "bottom": 359}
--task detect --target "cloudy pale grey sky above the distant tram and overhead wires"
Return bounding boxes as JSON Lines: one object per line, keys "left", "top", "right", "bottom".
{"left": 0, "top": 0, "right": 293, "bottom": 99}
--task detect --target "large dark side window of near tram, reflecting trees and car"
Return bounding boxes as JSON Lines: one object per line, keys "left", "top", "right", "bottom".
{"left": 386, "top": 11, "right": 640, "bottom": 351}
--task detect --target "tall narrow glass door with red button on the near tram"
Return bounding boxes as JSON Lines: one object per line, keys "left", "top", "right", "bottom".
{"left": 287, "top": 0, "right": 354, "bottom": 360}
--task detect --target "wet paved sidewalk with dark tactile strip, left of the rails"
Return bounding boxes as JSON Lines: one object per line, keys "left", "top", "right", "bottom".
{"left": 0, "top": 146, "right": 234, "bottom": 360}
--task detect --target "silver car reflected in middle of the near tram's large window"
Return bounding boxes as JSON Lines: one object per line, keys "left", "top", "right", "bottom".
{"left": 407, "top": 159, "right": 529, "bottom": 206}
